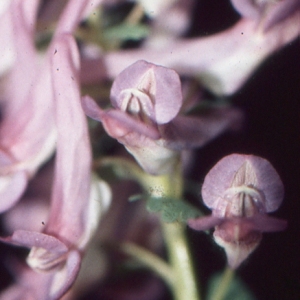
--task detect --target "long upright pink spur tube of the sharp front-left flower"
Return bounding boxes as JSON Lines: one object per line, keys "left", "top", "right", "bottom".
{"left": 45, "top": 34, "right": 91, "bottom": 244}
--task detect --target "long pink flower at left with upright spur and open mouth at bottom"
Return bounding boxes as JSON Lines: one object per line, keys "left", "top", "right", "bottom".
{"left": 0, "top": 26, "right": 110, "bottom": 300}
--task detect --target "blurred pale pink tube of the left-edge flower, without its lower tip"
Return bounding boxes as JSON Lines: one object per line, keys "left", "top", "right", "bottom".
{"left": 0, "top": 0, "right": 55, "bottom": 176}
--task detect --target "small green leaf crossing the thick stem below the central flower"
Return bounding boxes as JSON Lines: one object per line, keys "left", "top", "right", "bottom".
{"left": 147, "top": 197, "right": 202, "bottom": 223}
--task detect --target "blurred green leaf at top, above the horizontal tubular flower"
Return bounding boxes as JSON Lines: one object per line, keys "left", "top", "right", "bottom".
{"left": 104, "top": 23, "right": 149, "bottom": 41}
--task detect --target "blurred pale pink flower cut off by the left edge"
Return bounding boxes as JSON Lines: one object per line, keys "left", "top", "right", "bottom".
{"left": 0, "top": 0, "right": 56, "bottom": 212}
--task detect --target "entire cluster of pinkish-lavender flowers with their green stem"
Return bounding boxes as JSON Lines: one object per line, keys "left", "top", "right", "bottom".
{"left": 0, "top": 0, "right": 300, "bottom": 300}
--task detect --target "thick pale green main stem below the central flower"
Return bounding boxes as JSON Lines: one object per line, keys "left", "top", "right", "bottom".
{"left": 147, "top": 164, "right": 200, "bottom": 300}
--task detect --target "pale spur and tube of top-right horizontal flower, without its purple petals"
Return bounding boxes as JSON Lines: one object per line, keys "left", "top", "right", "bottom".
{"left": 101, "top": 12, "right": 300, "bottom": 94}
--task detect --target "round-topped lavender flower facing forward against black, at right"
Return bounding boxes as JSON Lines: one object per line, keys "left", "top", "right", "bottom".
{"left": 188, "top": 154, "right": 287, "bottom": 269}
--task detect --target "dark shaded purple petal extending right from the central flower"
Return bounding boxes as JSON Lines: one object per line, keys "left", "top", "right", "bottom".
{"left": 159, "top": 108, "right": 242, "bottom": 151}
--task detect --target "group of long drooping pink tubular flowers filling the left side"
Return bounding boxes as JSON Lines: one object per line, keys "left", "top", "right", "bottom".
{"left": 0, "top": 1, "right": 110, "bottom": 299}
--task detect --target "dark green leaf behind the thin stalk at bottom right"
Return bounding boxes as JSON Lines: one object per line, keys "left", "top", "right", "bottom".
{"left": 205, "top": 273, "right": 255, "bottom": 300}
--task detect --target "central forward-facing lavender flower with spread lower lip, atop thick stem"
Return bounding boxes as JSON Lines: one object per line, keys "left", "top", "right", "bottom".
{"left": 82, "top": 60, "right": 240, "bottom": 175}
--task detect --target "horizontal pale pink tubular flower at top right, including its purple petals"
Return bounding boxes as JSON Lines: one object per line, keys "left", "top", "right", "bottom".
{"left": 89, "top": 0, "right": 300, "bottom": 95}
